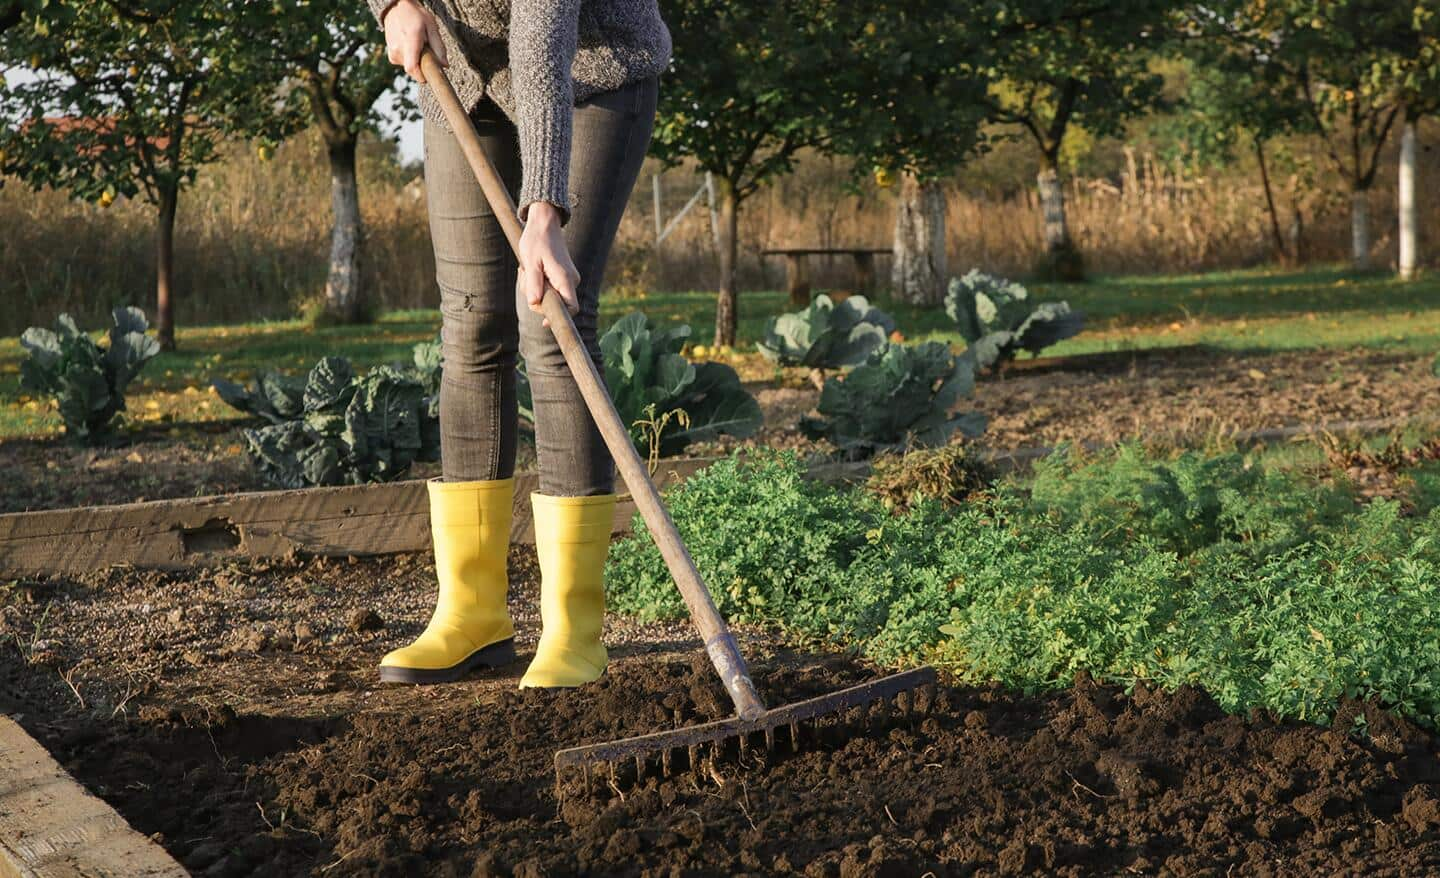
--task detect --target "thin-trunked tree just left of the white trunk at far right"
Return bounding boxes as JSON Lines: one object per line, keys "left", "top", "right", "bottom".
{"left": 1192, "top": 0, "right": 1408, "bottom": 268}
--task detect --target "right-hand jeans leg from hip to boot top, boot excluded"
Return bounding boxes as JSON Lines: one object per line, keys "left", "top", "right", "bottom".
{"left": 514, "top": 78, "right": 657, "bottom": 497}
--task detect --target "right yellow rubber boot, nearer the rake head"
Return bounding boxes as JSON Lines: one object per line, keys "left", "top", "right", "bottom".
{"left": 520, "top": 494, "right": 615, "bottom": 688}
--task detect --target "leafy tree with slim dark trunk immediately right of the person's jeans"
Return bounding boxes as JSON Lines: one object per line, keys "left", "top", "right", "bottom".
{"left": 651, "top": 0, "right": 860, "bottom": 344}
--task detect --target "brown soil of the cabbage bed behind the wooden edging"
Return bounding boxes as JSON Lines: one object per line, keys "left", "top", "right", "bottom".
{"left": 0, "top": 350, "right": 1440, "bottom": 512}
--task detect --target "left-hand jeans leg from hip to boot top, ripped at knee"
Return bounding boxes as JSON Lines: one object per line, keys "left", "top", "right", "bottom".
{"left": 425, "top": 107, "right": 520, "bottom": 481}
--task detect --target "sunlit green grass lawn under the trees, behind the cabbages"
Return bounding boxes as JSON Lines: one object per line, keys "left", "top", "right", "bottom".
{"left": 0, "top": 261, "right": 1440, "bottom": 438}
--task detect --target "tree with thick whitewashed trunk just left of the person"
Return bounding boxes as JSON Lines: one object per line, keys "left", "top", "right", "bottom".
{"left": 242, "top": 0, "right": 413, "bottom": 324}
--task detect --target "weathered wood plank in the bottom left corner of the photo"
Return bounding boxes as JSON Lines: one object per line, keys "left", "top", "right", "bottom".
{"left": 0, "top": 717, "right": 187, "bottom": 878}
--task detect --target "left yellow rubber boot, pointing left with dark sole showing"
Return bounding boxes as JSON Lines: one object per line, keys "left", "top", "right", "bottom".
{"left": 380, "top": 479, "right": 516, "bottom": 684}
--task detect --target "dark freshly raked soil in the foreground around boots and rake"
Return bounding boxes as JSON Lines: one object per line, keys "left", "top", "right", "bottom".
{"left": 0, "top": 550, "right": 1440, "bottom": 877}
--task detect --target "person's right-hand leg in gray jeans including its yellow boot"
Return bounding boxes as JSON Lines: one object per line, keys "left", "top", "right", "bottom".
{"left": 516, "top": 79, "right": 657, "bottom": 688}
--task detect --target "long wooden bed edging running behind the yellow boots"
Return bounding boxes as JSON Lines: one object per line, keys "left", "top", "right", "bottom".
{"left": 0, "top": 417, "right": 1416, "bottom": 577}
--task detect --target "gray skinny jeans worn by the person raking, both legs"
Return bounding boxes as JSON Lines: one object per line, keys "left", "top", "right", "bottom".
{"left": 425, "top": 78, "right": 657, "bottom": 497}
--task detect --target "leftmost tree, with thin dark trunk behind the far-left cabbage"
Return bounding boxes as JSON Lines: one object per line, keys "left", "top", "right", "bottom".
{"left": 0, "top": 0, "right": 286, "bottom": 350}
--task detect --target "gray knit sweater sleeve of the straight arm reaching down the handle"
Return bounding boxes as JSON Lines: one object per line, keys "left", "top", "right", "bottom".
{"left": 509, "top": 0, "right": 580, "bottom": 222}
